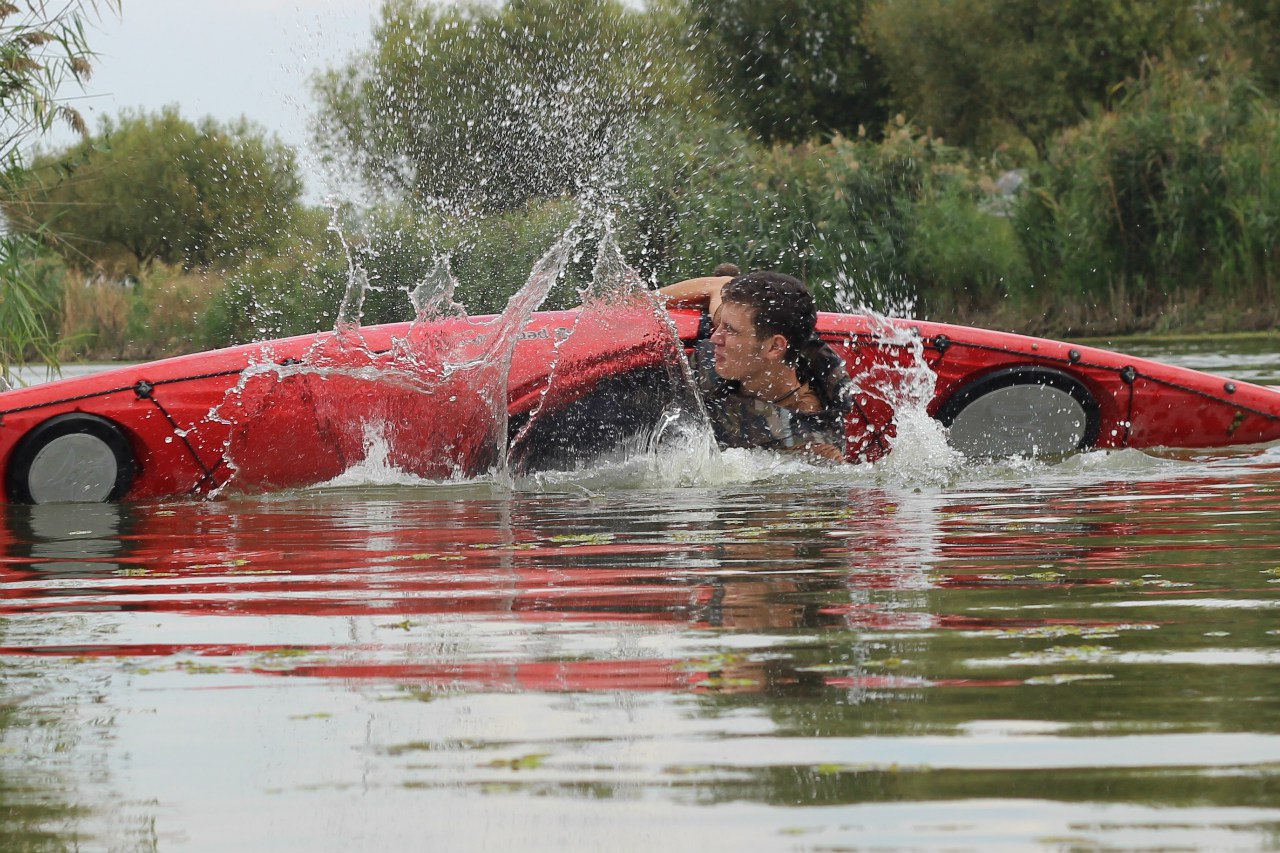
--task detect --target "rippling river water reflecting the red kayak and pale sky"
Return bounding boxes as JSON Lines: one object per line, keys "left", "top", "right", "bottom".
{"left": 0, "top": 342, "right": 1280, "bottom": 852}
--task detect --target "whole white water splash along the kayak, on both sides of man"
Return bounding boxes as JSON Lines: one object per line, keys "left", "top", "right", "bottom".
{"left": 204, "top": 215, "right": 964, "bottom": 489}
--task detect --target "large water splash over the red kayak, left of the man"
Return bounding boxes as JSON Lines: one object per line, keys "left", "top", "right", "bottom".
{"left": 202, "top": 211, "right": 742, "bottom": 491}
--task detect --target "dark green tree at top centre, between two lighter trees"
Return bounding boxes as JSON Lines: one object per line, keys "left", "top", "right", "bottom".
{"left": 690, "top": 0, "right": 888, "bottom": 141}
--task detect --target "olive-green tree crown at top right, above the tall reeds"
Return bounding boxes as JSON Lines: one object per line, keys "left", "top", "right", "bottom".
{"left": 867, "top": 0, "right": 1216, "bottom": 154}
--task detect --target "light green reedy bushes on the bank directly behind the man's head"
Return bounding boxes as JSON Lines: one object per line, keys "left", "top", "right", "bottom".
{"left": 637, "top": 119, "right": 1029, "bottom": 313}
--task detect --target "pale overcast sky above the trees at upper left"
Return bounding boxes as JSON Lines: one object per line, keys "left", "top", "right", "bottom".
{"left": 42, "top": 0, "right": 379, "bottom": 201}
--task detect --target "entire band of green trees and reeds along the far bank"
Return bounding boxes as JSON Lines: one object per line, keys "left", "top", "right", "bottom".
{"left": 0, "top": 0, "right": 1280, "bottom": 366}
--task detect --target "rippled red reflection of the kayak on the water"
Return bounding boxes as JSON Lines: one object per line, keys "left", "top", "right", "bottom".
{"left": 0, "top": 479, "right": 1208, "bottom": 693}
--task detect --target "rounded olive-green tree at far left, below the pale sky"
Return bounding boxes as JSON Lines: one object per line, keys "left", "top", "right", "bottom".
{"left": 4, "top": 106, "right": 302, "bottom": 266}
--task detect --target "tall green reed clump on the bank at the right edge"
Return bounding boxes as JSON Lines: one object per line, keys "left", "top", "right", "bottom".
{"left": 1019, "top": 61, "right": 1280, "bottom": 328}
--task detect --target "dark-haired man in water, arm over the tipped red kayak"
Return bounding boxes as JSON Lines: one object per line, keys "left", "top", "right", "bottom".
{"left": 659, "top": 268, "right": 854, "bottom": 461}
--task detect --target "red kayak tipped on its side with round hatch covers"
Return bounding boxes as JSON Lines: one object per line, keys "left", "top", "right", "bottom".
{"left": 0, "top": 306, "right": 1280, "bottom": 502}
